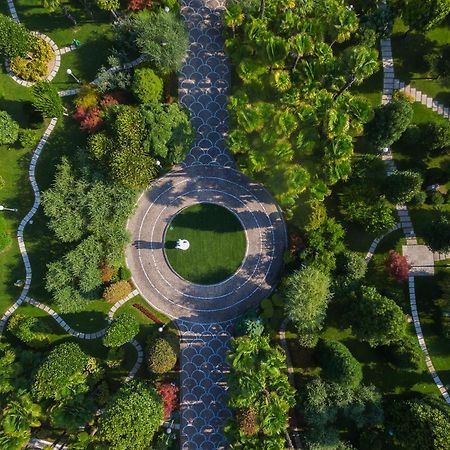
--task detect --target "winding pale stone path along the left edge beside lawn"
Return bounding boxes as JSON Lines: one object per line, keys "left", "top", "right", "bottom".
{"left": 0, "top": 118, "right": 58, "bottom": 335}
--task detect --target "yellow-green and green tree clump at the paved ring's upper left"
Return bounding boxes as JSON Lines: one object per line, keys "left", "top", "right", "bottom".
{"left": 89, "top": 103, "right": 192, "bottom": 188}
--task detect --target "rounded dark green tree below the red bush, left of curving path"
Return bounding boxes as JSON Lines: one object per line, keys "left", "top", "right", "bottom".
{"left": 350, "top": 286, "right": 406, "bottom": 347}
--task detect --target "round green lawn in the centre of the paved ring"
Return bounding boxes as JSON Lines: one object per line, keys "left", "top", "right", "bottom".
{"left": 164, "top": 203, "right": 247, "bottom": 284}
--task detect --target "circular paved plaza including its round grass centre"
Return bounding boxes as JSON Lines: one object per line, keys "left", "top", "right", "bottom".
{"left": 127, "top": 166, "right": 286, "bottom": 323}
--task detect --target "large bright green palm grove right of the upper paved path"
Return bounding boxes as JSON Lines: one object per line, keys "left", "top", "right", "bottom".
{"left": 225, "top": 0, "right": 378, "bottom": 214}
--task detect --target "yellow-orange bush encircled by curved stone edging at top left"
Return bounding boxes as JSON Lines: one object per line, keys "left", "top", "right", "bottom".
{"left": 10, "top": 37, "right": 55, "bottom": 81}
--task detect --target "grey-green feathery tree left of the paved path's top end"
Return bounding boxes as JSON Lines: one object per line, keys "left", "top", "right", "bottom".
{"left": 133, "top": 10, "right": 188, "bottom": 71}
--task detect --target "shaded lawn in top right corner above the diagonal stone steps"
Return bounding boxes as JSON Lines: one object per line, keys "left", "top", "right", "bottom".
{"left": 392, "top": 18, "right": 450, "bottom": 106}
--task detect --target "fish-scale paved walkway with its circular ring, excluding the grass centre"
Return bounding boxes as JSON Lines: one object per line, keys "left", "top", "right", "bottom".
{"left": 127, "top": 0, "right": 286, "bottom": 450}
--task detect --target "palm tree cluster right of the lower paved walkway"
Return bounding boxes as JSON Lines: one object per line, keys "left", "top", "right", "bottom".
{"left": 226, "top": 336, "right": 295, "bottom": 449}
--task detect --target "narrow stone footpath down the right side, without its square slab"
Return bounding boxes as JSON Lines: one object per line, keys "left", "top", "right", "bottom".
{"left": 380, "top": 14, "right": 450, "bottom": 405}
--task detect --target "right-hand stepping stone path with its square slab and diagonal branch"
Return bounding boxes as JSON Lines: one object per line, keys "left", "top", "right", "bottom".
{"left": 380, "top": 9, "right": 450, "bottom": 405}
